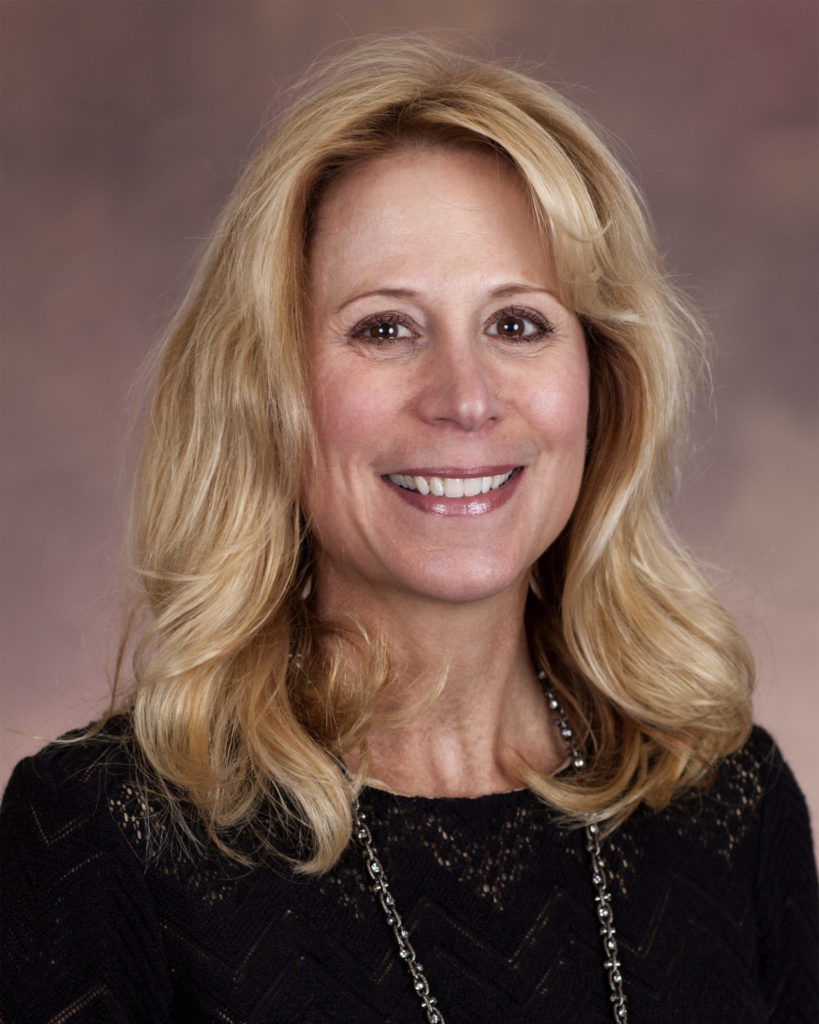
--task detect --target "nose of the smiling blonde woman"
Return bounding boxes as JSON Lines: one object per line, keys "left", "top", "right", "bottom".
{"left": 418, "top": 338, "right": 501, "bottom": 431}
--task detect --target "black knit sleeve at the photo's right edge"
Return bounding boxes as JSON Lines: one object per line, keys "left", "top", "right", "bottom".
{"left": 756, "top": 730, "right": 819, "bottom": 1024}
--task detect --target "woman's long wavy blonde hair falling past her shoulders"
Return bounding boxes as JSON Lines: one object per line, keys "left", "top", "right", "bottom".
{"left": 115, "top": 39, "right": 751, "bottom": 871}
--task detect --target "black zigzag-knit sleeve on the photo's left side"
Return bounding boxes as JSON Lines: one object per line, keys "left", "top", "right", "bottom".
{"left": 0, "top": 746, "right": 172, "bottom": 1024}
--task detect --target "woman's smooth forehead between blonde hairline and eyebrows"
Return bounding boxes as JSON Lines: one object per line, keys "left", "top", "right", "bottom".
{"left": 309, "top": 146, "right": 548, "bottom": 301}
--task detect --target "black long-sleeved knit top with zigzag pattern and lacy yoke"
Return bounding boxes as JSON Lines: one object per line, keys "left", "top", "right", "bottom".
{"left": 0, "top": 729, "right": 819, "bottom": 1024}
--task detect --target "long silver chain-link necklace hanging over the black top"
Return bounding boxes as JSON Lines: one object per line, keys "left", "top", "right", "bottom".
{"left": 353, "top": 672, "right": 629, "bottom": 1024}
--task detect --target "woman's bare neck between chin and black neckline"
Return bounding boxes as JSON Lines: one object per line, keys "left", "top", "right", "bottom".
{"left": 315, "top": 588, "right": 565, "bottom": 797}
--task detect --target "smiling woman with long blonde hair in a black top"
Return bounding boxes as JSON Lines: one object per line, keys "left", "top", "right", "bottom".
{"left": 3, "top": 40, "right": 817, "bottom": 1024}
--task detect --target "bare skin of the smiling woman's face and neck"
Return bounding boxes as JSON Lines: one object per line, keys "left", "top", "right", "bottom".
{"left": 304, "top": 147, "right": 589, "bottom": 796}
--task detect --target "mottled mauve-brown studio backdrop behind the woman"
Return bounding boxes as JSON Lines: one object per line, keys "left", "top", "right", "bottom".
{"left": 0, "top": 0, "right": 819, "bottom": 820}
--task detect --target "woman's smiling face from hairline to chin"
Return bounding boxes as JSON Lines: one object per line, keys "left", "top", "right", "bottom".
{"left": 304, "top": 148, "right": 589, "bottom": 611}
